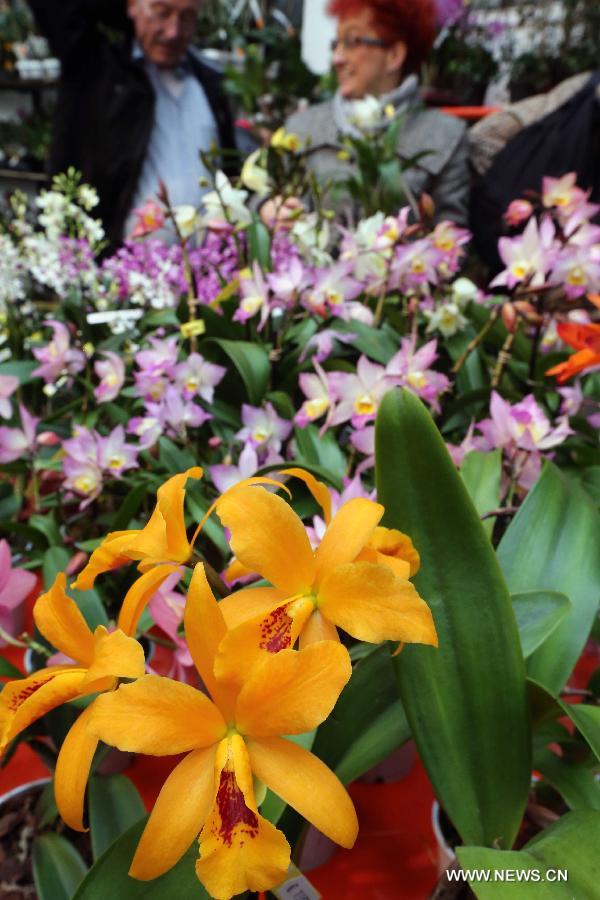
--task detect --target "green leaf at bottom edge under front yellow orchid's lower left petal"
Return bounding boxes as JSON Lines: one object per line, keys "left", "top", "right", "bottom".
{"left": 72, "top": 819, "right": 208, "bottom": 900}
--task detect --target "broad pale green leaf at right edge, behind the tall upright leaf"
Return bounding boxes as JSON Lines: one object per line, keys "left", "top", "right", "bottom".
{"left": 498, "top": 462, "right": 600, "bottom": 694}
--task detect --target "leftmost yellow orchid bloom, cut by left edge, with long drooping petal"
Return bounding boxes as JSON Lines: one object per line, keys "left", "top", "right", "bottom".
{"left": 0, "top": 566, "right": 177, "bottom": 831}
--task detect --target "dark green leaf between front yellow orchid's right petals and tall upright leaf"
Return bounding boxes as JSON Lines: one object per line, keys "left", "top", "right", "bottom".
{"left": 335, "top": 700, "right": 411, "bottom": 784}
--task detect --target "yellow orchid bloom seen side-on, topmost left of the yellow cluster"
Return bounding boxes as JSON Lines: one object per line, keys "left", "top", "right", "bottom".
{"left": 72, "top": 466, "right": 203, "bottom": 591}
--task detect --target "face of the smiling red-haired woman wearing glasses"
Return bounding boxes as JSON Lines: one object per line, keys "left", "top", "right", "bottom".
{"left": 332, "top": 9, "right": 406, "bottom": 100}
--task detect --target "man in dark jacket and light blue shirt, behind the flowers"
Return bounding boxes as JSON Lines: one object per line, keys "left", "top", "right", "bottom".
{"left": 30, "top": 0, "right": 234, "bottom": 245}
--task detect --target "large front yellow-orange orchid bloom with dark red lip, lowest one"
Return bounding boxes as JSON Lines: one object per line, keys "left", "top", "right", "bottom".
{"left": 88, "top": 563, "right": 358, "bottom": 900}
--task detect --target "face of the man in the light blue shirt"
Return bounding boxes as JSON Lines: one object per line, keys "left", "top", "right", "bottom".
{"left": 127, "top": 0, "right": 200, "bottom": 69}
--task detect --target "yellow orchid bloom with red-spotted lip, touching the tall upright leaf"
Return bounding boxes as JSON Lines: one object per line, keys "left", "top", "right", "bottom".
{"left": 216, "top": 486, "right": 437, "bottom": 682}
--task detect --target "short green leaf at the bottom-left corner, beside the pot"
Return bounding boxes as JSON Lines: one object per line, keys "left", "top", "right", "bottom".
{"left": 32, "top": 832, "right": 87, "bottom": 900}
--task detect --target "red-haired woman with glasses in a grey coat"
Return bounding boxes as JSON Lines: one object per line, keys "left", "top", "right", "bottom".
{"left": 276, "top": 0, "right": 469, "bottom": 225}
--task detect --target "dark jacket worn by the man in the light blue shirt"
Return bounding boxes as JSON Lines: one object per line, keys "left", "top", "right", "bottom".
{"left": 30, "top": 0, "right": 235, "bottom": 245}
